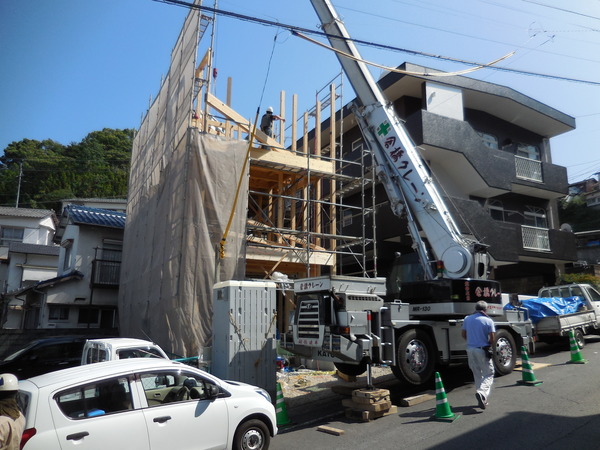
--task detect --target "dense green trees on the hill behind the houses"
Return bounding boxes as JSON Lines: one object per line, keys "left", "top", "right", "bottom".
{"left": 0, "top": 128, "right": 134, "bottom": 213}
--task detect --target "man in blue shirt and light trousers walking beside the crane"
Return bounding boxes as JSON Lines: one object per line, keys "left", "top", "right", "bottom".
{"left": 462, "top": 300, "right": 496, "bottom": 409}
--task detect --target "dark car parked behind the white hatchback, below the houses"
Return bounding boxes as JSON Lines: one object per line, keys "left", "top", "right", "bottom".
{"left": 0, "top": 336, "right": 98, "bottom": 380}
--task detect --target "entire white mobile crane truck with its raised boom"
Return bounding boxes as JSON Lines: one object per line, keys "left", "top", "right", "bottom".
{"left": 282, "top": 0, "right": 534, "bottom": 385}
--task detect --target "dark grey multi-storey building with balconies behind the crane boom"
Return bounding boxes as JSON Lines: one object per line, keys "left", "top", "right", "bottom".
{"left": 321, "top": 63, "right": 577, "bottom": 293}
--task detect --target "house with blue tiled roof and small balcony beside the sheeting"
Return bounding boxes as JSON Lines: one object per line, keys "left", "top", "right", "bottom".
{"left": 1, "top": 204, "right": 125, "bottom": 329}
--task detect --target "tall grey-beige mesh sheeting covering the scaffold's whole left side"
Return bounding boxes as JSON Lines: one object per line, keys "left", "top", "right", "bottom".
{"left": 119, "top": 0, "right": 248, "bottom": 356}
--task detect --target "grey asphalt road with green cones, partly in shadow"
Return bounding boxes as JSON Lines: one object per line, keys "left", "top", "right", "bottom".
{"left": 271, "top": 336, "right": 600, "bottom": 450}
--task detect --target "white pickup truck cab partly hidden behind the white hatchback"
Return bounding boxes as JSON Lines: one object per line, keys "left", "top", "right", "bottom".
{"left": 81, "top": 338, "right": 169, "bottom": 365}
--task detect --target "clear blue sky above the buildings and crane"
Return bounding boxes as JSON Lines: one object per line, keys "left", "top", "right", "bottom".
{"left": 0, "top": 0, "right": 600, "bottom": 182}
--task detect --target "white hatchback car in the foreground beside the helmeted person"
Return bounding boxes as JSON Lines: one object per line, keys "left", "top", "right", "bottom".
{"left": 19, "top": 358, "right": 277, "bottom": 450}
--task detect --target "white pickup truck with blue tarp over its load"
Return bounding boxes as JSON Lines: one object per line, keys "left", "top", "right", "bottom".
{"left": 508, "top": 284, "right": 600, "bottom": 348}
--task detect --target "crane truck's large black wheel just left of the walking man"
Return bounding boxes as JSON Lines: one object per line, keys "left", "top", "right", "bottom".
{"left": 392, "top": 328, "right": 435, "bottom": 385}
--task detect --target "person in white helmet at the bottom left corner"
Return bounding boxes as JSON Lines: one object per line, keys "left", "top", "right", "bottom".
{"left": 0, "top": 373, "right": 25, "bottom": 450}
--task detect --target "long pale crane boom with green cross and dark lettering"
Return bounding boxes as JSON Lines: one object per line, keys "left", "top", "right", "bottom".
{"left": 311, "top": 0, "right": 487, "bottom": 279}
